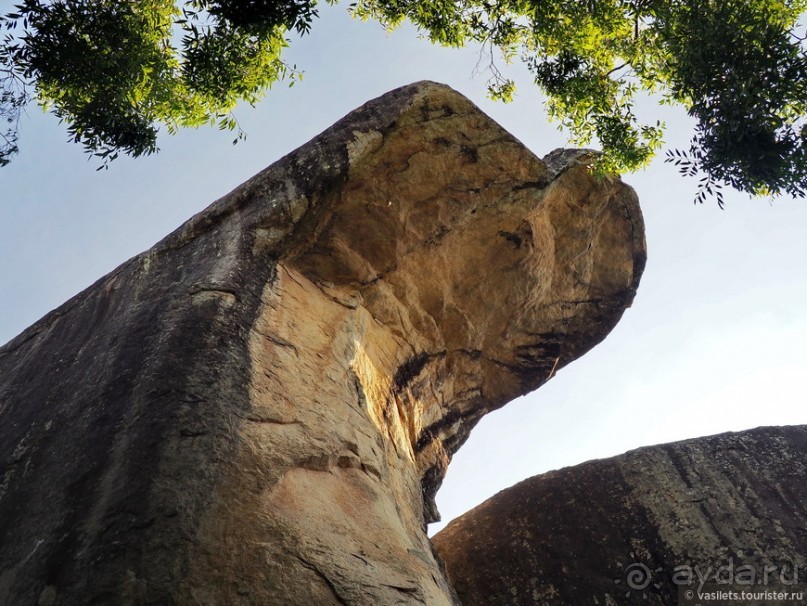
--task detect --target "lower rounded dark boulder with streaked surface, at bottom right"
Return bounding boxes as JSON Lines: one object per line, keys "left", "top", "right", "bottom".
{"left": 434, "top": 426, "right": 807, "bottom": 606}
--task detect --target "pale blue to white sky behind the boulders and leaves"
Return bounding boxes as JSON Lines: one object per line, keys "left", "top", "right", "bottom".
{"left": 0, "top": 1, "right": 807, "bottom": 530}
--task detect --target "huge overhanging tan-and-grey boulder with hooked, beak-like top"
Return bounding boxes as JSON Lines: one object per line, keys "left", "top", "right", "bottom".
{"left": 0, "top": 83, "right": 645, "bottom": 606}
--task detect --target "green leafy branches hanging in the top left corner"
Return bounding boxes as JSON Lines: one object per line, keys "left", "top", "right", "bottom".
{"left": 3, "top": 0, "right": 315, "bottom": 160}
